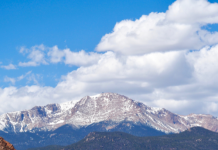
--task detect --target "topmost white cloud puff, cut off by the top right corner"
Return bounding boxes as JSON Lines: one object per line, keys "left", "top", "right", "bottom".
{"left": 166, "top": 0, "right": 218, "bottom": 24}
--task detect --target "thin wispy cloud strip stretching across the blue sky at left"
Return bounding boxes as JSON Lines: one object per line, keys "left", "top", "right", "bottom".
{"left": 19, "top": 44, "right": 101, "bottom": 67}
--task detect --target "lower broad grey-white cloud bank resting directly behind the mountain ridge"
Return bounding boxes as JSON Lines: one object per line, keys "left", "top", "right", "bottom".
{"left": 0, "top": 45, "right": 218, "bottom": 116}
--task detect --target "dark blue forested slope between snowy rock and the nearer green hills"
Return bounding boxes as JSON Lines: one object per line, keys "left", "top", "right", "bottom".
{"left": 0, "top": 121, "right": 165, "bottom": 150}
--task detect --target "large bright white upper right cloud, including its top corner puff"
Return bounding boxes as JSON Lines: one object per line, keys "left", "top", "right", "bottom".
{"left": 96, "top": 0, "right": 218, "bottom": 55}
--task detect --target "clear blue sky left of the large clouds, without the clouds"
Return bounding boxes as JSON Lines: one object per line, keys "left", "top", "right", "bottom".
{"left": 0, "top": 0, "right": 179, "bottom": 87}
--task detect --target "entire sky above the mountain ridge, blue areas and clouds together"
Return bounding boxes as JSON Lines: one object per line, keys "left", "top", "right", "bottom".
{"left": 0, "top": 0, "right": 218, "bottom": 116}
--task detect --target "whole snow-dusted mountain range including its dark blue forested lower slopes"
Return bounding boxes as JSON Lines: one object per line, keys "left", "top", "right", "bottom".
{"left": 0, "top": 93, "right": 218, "bottom": 150}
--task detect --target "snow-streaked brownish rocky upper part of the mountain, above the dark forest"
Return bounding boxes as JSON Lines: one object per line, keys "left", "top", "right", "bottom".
{"left": 0, "top": 93, "right": 218, "bottom": 133}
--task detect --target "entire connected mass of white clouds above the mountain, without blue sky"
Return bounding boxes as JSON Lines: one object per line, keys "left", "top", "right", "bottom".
{"left": 0, "top": 0, "right": 218, "bottom": 116}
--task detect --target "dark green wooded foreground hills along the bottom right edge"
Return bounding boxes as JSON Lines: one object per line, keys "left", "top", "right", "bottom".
{"left": 28, "top": 127, "right": 218, "bottom": 150}
